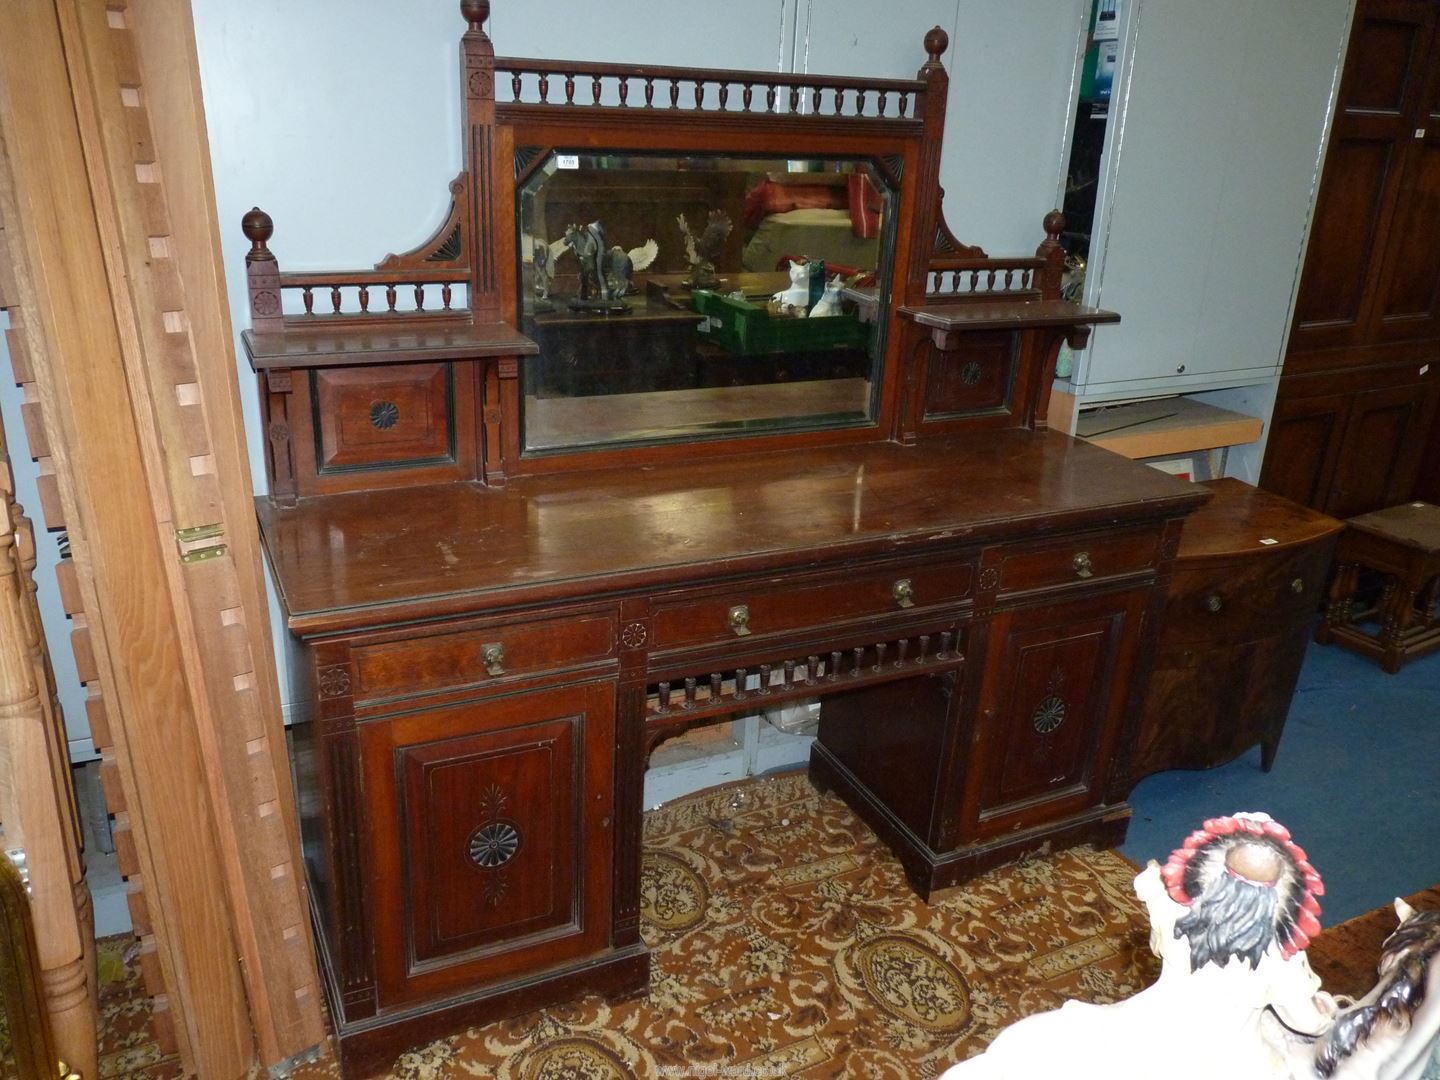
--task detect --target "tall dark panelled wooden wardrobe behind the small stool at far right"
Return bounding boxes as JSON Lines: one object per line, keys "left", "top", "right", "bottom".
{"left": 1260, "top": 0, "right": 1440, "bottom": 517}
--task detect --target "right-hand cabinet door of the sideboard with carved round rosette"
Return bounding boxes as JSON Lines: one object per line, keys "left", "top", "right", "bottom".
{"left": 971, "top": 590, "right": 1145, "bottom": 838}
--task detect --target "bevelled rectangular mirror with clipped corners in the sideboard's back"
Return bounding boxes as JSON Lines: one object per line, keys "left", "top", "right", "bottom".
{"left": 516, "top": 150, "right": 897, "bottom": 455}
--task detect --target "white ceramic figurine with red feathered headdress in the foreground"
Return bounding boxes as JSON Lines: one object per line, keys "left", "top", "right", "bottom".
{"left": 940, "top": 814, "right": 1440, "bottom": 1080}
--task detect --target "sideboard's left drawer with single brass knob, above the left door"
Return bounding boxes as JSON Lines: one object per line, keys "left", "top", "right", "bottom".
{"left": 351, "top": 611, "right": 615, "bottom": 701}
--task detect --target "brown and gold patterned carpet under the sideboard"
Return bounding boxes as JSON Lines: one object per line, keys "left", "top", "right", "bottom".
{"left": 90, "top": 775, "right": 1440, "bottom": 1080}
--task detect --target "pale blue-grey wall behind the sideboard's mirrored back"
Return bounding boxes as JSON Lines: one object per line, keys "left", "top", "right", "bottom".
{"left": 193, "top": 0, "right": 1087, "bottom": 728}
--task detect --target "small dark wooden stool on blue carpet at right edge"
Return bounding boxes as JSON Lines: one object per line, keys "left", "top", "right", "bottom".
{"left": 1315, "top": 503, "right": 1440, "bottom": 675}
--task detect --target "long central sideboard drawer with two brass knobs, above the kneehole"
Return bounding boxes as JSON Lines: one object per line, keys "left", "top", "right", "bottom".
{"left": 655, "top": 562, "right": 975, "bottom": 648}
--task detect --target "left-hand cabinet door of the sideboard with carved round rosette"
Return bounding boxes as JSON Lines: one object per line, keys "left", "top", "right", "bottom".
{"left": 360, "top": 683, "right": 615, "bottom": 1005}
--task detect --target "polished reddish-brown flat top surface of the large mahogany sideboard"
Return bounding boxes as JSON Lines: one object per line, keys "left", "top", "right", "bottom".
{"left": 256, "top": 429, "right": 1208, "bottom": 635}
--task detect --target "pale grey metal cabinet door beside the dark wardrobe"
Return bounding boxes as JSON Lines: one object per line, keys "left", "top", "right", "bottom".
{"left": 1071, "top": 0, "right": 1352, "bottom": 399}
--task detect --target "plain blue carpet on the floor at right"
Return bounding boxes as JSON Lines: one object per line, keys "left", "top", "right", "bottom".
{"left": 1120, "top": 644, "right": 1440, "bottom": 926}
